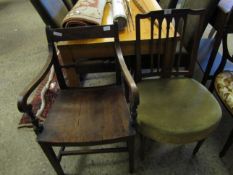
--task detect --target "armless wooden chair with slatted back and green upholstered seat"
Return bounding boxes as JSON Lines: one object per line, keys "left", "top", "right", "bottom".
{"left": 134, "top": 9, "right": 222, "bottom": 155}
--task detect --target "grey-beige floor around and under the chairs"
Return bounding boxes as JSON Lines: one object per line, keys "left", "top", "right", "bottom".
{"left": 0, "top": 0, "right": 233, "bottom": 175}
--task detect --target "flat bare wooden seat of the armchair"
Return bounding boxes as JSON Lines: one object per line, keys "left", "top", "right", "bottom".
{"left": 37, "top": 87, "right": 135, "bottom": 145}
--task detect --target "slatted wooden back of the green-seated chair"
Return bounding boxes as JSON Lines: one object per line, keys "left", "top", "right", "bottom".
{"left": 135, "top": 9, "right": 205, "bottom": 81}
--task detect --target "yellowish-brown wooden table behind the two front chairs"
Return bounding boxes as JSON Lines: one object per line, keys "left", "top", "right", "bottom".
{"left": 57, "top": 0, "right": 172, "bottom": 86}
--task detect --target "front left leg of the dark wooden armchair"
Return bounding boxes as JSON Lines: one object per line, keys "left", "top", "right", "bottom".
{"left": 40, "top": 143, "right": 65, "bottom": 175}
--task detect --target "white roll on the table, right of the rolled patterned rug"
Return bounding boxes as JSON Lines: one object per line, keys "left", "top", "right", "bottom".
{"left": 112, "top": 0, "right": 127, "bottom": 30}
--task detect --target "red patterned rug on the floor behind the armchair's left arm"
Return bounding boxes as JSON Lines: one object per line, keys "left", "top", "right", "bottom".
{"left": 18, "top": 77, "right": 59, "bottom": 128}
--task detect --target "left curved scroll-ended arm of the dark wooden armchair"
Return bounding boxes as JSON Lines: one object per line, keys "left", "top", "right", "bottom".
{"left": 17, "top": 46, "right": 53, "bottom": 113}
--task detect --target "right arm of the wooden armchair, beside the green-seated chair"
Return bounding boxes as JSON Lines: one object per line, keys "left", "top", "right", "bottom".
{"left": 115, "top": 42, "right": 139, "bottom": 125}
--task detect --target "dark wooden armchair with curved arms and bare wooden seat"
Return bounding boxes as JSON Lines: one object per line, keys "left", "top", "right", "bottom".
{"left": 18, "top": 23, "right": 139, "bottom": 175}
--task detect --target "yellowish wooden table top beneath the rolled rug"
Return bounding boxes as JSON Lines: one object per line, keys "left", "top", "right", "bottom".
{"left": 58, "top": 0, "right": 171, "bottom": 46}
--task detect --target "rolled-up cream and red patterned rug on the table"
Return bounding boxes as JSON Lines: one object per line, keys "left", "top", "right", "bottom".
{"left": 63, "top": 0, "right": 106, "bottom": 27}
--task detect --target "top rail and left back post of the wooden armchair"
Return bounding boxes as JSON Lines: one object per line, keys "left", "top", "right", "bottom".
{"left": 46, "top": 22, "right": 119, "bottom": 89}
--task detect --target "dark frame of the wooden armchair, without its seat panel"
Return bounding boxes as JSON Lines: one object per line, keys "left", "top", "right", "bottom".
{"left": 18, "top": 22, "right": 139, "bottom": 175}
